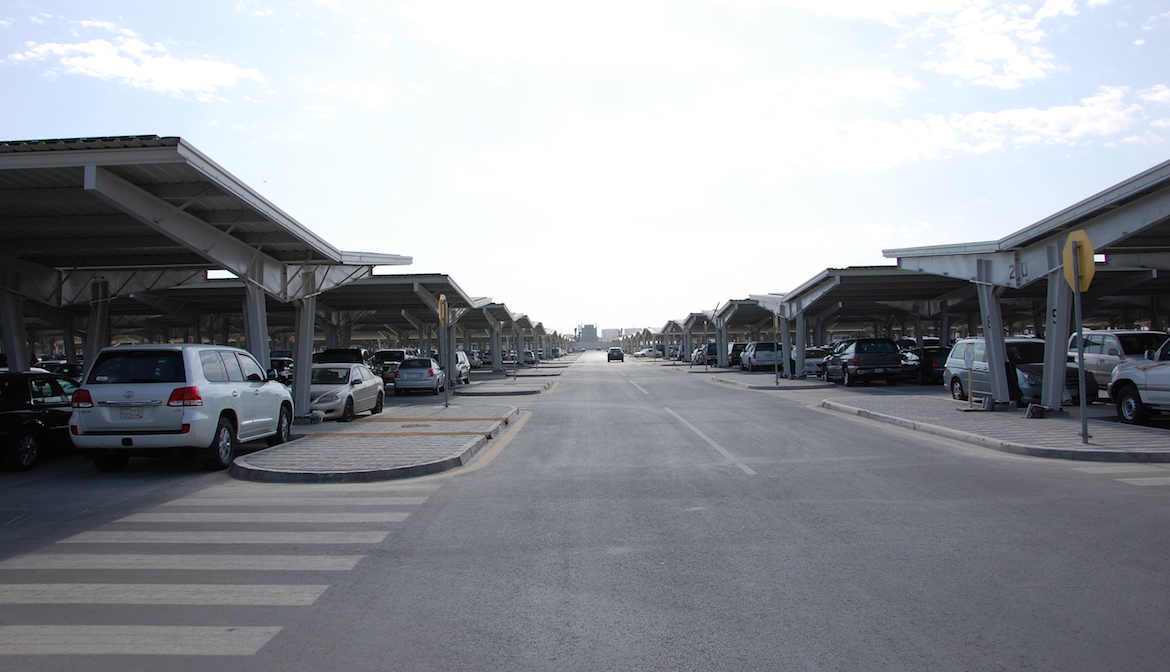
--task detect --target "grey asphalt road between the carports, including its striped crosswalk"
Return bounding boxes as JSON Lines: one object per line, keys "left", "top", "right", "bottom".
{"left": 0, "top": 352, "right": 1170, "bottom": 672}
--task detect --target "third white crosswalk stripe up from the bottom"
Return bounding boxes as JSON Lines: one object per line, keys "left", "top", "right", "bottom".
{"left": 0, "top": 553, "right": 365, "bottom": 571}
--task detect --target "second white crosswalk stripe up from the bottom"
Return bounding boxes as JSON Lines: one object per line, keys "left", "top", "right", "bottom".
{"left": 0, "top": 583, "right": 329, "bottom": 606}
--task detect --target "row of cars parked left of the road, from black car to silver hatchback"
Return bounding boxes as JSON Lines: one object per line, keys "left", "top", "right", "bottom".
{"left": 0, "top": 343, "right": 484, "bottom": 471}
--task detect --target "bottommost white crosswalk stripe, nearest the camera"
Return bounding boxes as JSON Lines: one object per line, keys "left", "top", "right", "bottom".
{"left": 0, "top": 625, "right": 281, "bottom": 656}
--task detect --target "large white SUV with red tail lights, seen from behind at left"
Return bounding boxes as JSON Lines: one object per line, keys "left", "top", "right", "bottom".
{"left": 69, "top": 343, "right": 293, "bottom": 471}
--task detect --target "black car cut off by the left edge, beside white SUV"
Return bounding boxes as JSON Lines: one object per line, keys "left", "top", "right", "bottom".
{"left": 0, "top": 371, "right": 78, "bottom": 472}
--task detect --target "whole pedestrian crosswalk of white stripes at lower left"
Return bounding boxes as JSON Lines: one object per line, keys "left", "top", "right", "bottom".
{"left": 0, "top": 482, "right": 439, "bottom": 667}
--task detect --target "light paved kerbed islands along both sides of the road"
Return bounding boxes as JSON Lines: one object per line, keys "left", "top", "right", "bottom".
{"left": 229, "top": 362, "right": 1170, "bottom": 482}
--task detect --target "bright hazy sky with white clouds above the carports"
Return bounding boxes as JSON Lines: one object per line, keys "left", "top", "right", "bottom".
{"left": 0, "top": 0, "right": 1170, "bottom": 335}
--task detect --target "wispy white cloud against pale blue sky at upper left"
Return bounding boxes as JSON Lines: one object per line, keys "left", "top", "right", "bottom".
{"left": 8, "top": 30, "right": 264, "bottom": 101}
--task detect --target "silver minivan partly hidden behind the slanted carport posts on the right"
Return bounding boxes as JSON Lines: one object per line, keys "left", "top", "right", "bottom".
{"left": 943, "top": 337, "right": 1099, "bottom": 404}
